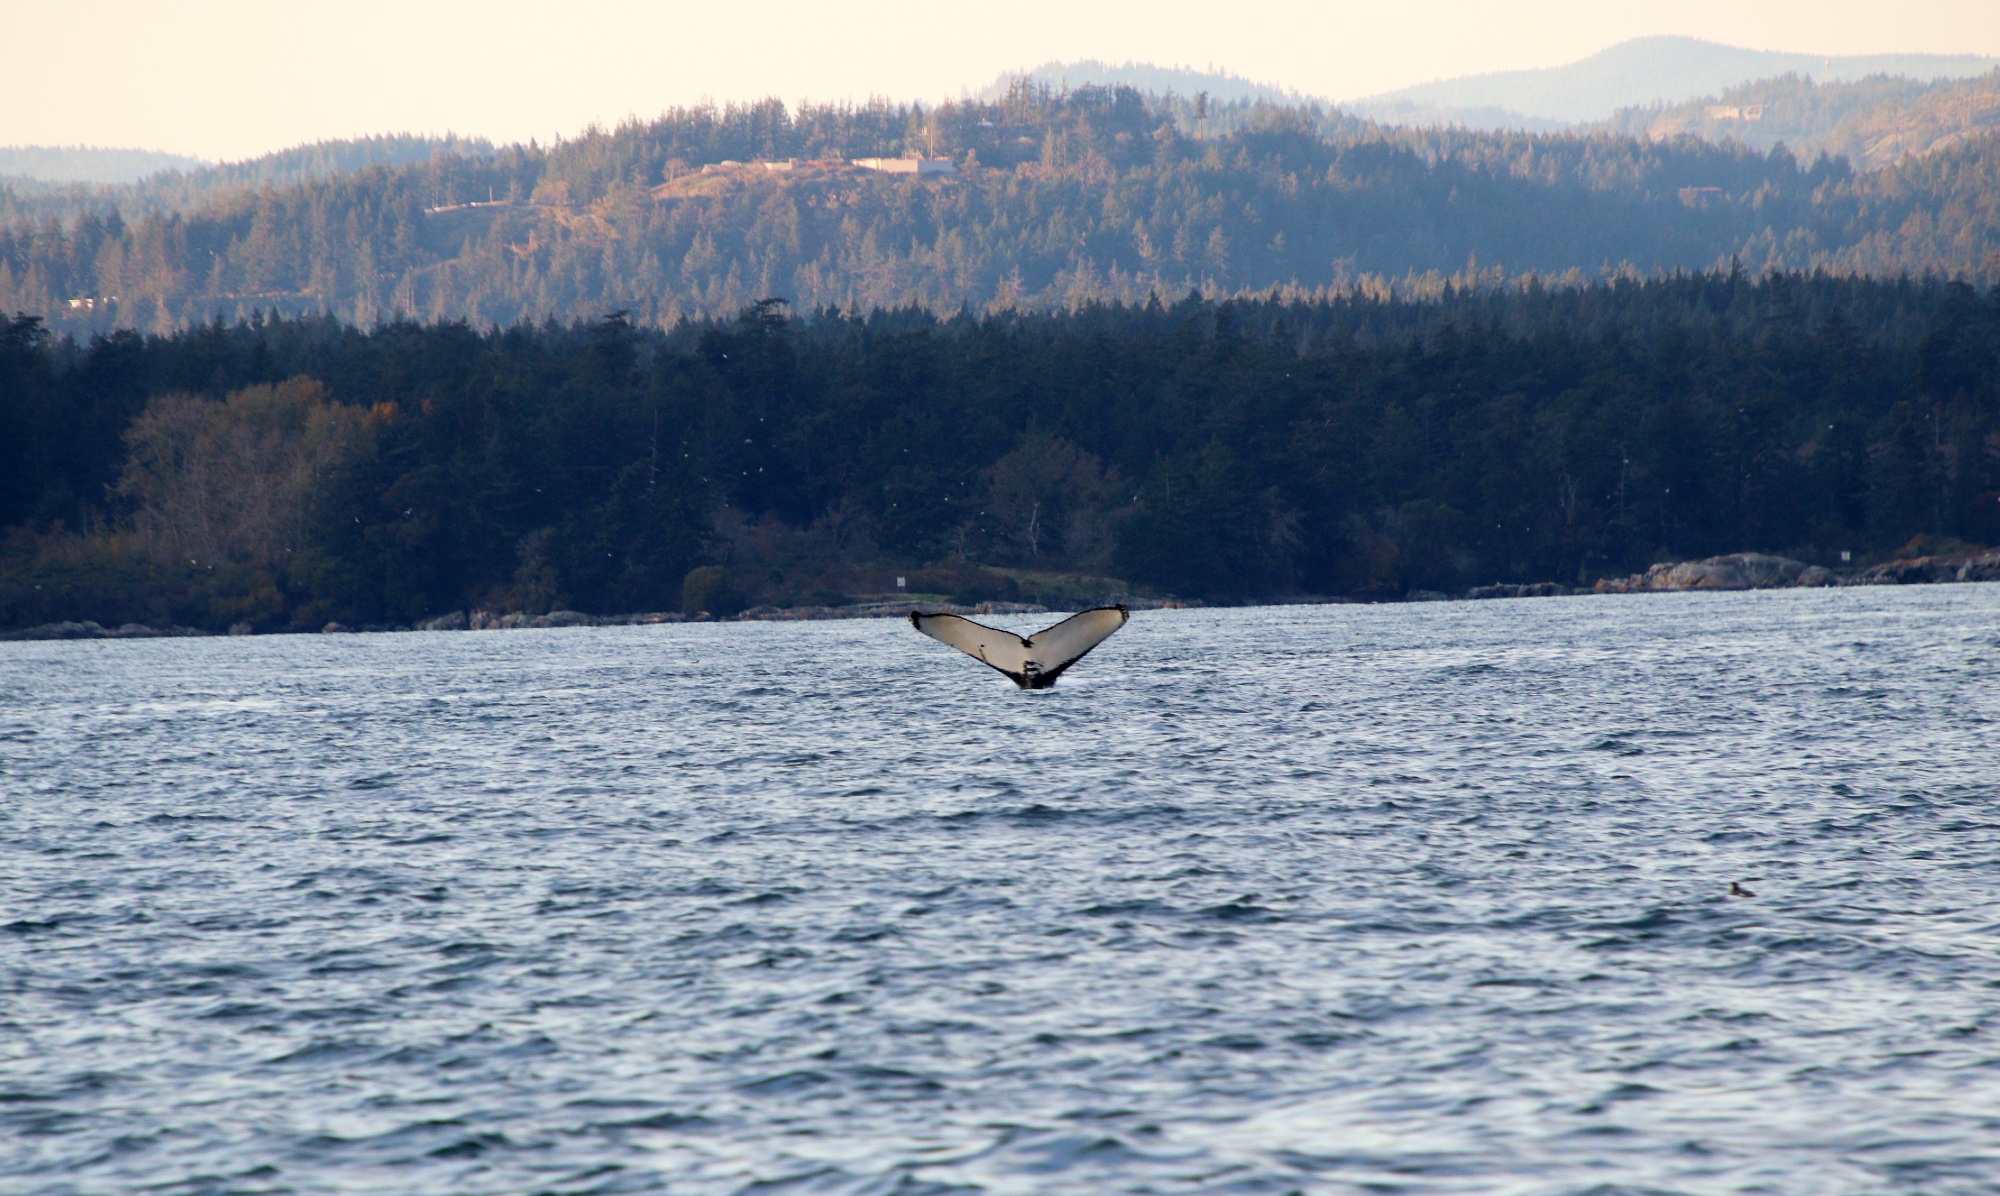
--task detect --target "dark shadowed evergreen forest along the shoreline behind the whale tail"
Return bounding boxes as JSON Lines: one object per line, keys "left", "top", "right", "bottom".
{"left": 0, "top": 272, "right": 2000, "bottom": 628}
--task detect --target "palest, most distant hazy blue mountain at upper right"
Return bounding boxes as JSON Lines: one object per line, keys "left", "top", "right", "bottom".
{"left": 1344, "top": 38, "right": 2000, "bottom": 128}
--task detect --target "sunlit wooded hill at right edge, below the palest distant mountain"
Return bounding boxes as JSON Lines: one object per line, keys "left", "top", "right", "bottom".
{"left": 1594, "top": 70, "right": 2000, "bottom": 170}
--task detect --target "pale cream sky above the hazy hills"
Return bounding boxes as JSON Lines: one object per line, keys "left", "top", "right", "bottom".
{"left": 0, "top": 0, "right": 2000, "bottom": 160}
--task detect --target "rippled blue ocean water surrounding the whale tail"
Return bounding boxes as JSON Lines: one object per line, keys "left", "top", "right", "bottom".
{"left": 0, "top": 586, "right": 2000, "bottom": 1196}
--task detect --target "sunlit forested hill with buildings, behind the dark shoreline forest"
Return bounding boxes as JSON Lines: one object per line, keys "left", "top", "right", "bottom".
{"left": 11, "top": 82, "right": 2000, "bottom": 332}
